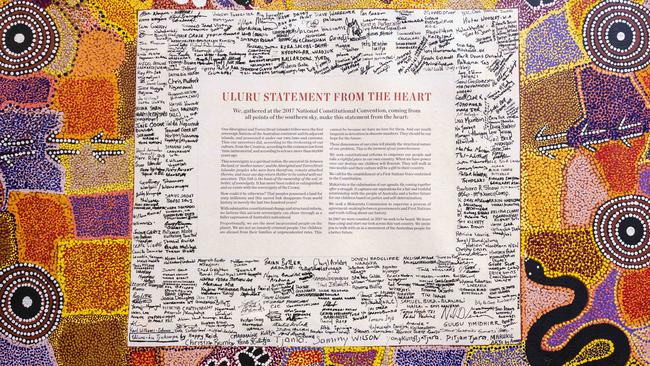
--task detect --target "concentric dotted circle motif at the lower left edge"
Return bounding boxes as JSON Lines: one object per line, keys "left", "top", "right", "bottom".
{"left": 0, "top": 264, "right": 63, "bottom": 344}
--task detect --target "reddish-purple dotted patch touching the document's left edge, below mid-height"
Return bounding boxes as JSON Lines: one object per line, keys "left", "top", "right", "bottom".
{"left": 70, "top": 193, "right": 131, "bottom": 238}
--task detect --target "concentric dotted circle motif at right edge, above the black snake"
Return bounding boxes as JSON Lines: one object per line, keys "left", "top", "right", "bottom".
{"left": 593, "top": 195, "right": 650, "bottom": 269}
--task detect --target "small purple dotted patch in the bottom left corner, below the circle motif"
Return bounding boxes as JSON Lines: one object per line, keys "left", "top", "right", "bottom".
{"left": 0, "top": 337, "right": 56, "bottom": 366}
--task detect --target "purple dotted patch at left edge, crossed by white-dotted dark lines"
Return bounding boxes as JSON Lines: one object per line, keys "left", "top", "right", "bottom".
{"left": 0, "top": 108, "right": 63, "bottom": 192}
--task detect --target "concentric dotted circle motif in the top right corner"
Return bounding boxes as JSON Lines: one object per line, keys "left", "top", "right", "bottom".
{"left": 582, "top": 0, "right": 650, "bottom": 73}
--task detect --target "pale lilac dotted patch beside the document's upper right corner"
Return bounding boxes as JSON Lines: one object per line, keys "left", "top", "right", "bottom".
{"left": 525, "top": 12, "right": 583, "bottom": 74}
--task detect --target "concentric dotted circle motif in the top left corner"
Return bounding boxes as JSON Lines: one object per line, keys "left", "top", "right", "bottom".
{"left": 0, "top": 0, "right": 59, "bottom": 76}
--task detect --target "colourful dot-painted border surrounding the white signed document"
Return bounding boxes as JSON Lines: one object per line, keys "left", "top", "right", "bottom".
{"left": 0, "top": 0, "right": 650, "bottom": 366}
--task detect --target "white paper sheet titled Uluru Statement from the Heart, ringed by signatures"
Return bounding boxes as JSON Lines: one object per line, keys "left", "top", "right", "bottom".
{"left": 129, "top": 10, "right": 520, "bottom": 346}
